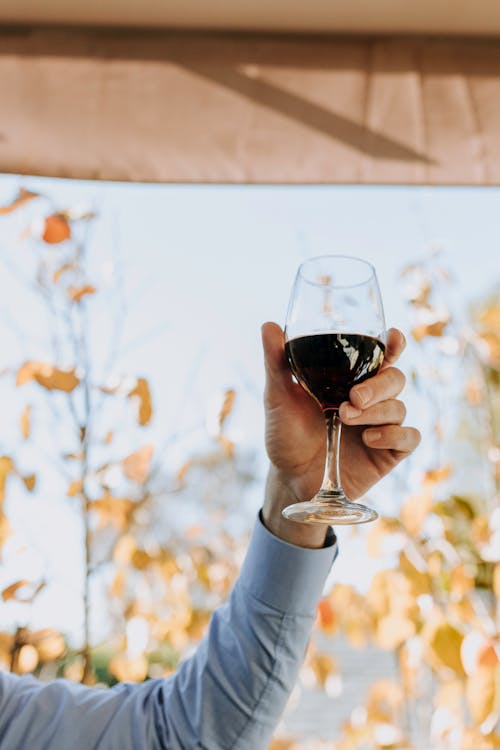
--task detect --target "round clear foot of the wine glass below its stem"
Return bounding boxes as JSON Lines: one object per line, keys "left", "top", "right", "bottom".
{"left": 282, "top": 492, "right": 378, "bottom": 526}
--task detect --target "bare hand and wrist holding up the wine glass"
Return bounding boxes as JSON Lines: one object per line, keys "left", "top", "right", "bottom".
{"left": 262, "top": 323, "right": 420, "bottom": 546}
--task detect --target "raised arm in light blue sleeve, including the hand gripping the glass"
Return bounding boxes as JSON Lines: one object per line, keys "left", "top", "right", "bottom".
{"left": 0, "top": 323, "right": 419, "bottom": 750}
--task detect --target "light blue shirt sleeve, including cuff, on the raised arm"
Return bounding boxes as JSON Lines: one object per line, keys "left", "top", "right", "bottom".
{"left": 0, "top": 520, "right": 337, "bottom": 750}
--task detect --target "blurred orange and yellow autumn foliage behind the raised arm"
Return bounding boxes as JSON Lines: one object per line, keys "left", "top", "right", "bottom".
{"left": 0, "top": 190, "right": 500, "bottom": 750}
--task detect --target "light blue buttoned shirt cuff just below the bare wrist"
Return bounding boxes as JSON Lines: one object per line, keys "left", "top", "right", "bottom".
{"left": 239, "top": 514, "right": 338, "bottom": 615}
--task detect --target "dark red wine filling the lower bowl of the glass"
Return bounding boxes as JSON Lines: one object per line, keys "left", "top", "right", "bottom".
{"left": 285, "top": 333, "right": 385, "bottom": 411}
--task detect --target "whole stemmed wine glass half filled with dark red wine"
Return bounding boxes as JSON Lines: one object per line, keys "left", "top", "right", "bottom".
{"left": 283, "top": 255, "right": 386, "bottom": 524}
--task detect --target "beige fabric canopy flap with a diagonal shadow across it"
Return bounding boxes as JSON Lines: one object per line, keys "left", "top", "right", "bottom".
{"left": 0, "top": 27, "right": 500, "bottom": 185}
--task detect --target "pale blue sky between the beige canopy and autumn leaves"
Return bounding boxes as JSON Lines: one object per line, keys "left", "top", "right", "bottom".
{"left": 0, "top": 175, "right": 500, "bottom": 631}
